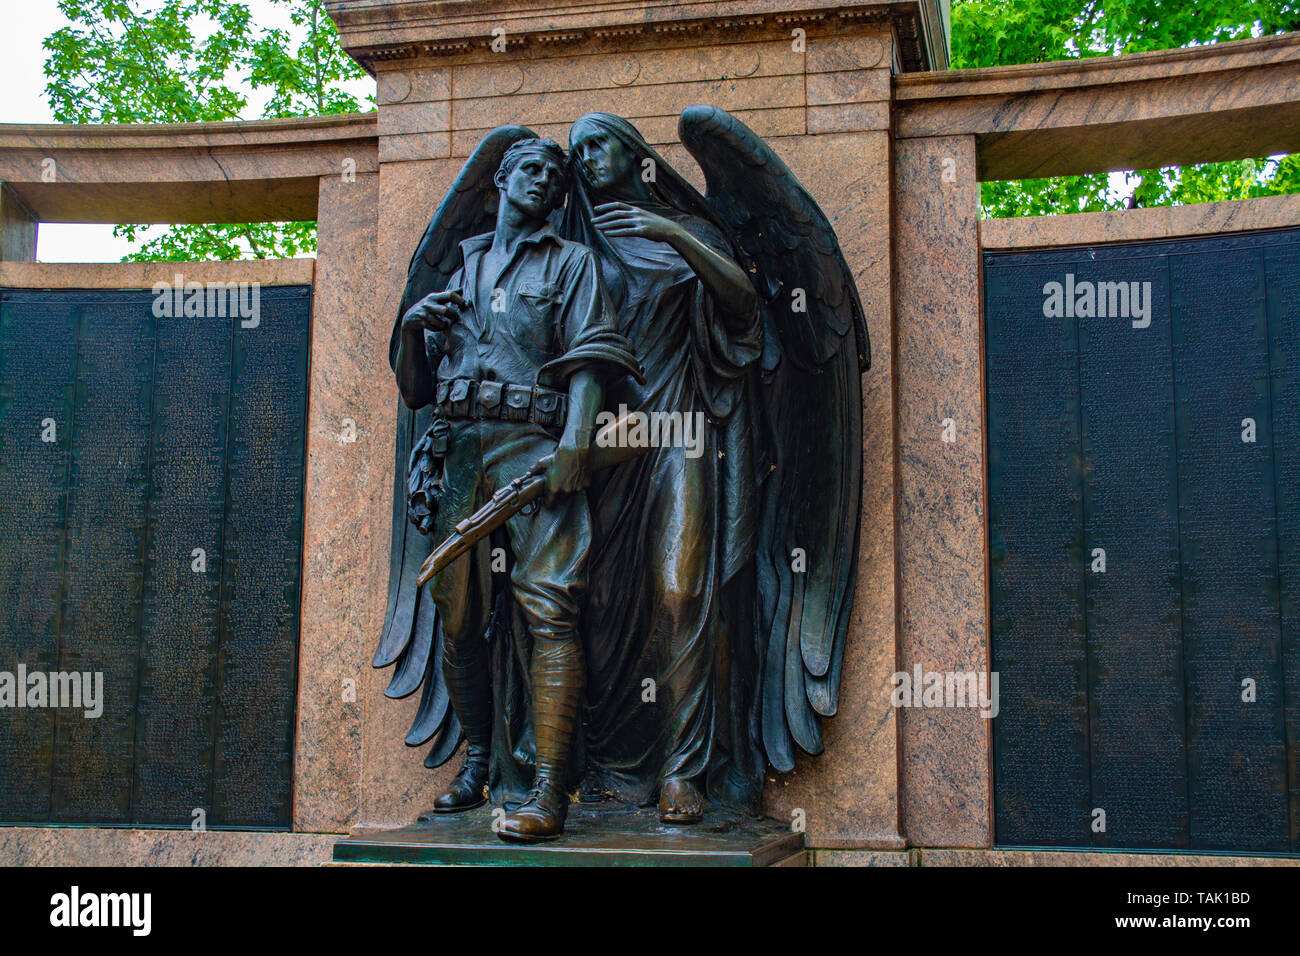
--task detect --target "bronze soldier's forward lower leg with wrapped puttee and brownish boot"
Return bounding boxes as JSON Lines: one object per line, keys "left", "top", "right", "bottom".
{"left": 498, "top": 635, "right": 585, "bottom": 843}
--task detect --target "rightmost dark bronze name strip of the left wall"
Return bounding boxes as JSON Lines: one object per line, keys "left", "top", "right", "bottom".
{"left": 211, "top": 287, "right": 311, "bottom": 826}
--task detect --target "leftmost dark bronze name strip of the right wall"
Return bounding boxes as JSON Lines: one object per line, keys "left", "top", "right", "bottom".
{"left": 985, "top": 252, "right": 1091, "bottom": 845}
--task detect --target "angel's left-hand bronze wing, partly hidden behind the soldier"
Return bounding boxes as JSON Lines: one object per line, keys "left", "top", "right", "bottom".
{"left": 372, "top": 126, "right": 536, "bottom": 767}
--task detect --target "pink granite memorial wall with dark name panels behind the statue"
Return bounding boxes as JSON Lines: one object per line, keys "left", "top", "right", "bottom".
{"left": 0, "top": 0, "right": 1300, "bottom": 866}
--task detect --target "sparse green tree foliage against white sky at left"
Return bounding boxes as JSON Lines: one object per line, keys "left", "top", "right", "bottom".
{"left": 44, "top": 0, "right": 373, "bottom": 261}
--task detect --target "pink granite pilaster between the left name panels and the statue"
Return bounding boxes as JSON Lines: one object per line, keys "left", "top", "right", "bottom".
{"left": 294, "top": 169, "right": 379, "bottom": 832}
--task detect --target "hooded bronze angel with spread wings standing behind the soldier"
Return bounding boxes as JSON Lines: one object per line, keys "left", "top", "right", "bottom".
{"left": 374, "top": 107, "right": 870, "bottom": 825}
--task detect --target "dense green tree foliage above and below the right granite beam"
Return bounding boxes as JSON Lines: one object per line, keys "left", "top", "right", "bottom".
{"left": 953, "top": 0, "right": 1300, "bottom": 216}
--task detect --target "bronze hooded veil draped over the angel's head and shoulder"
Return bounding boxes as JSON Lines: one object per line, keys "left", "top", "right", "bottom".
{"left": 560, "top": 113, "right": 736, "bottom": 299}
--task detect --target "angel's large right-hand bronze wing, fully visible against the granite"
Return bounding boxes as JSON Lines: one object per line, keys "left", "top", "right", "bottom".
{"left": 677, "top": 105, "right": 871, "bottom": 770}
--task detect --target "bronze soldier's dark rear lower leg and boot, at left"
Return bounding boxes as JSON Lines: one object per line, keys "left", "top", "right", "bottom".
{"left": 420, "top": 637, "right": 491, "bottom": 819}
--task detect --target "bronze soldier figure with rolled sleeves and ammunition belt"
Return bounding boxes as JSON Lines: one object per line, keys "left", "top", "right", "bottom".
{"left": 397, "top": 138, "right": 638, "bottom": 842}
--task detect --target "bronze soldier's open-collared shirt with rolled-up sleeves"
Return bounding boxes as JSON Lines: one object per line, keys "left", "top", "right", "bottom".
{"left": 425, "top": 222, "right": 640, "bottom": 388}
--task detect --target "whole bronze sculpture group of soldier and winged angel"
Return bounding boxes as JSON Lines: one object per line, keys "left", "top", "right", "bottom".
{"left": 374, "top": 107, "right": 870, "bottom": 839}
